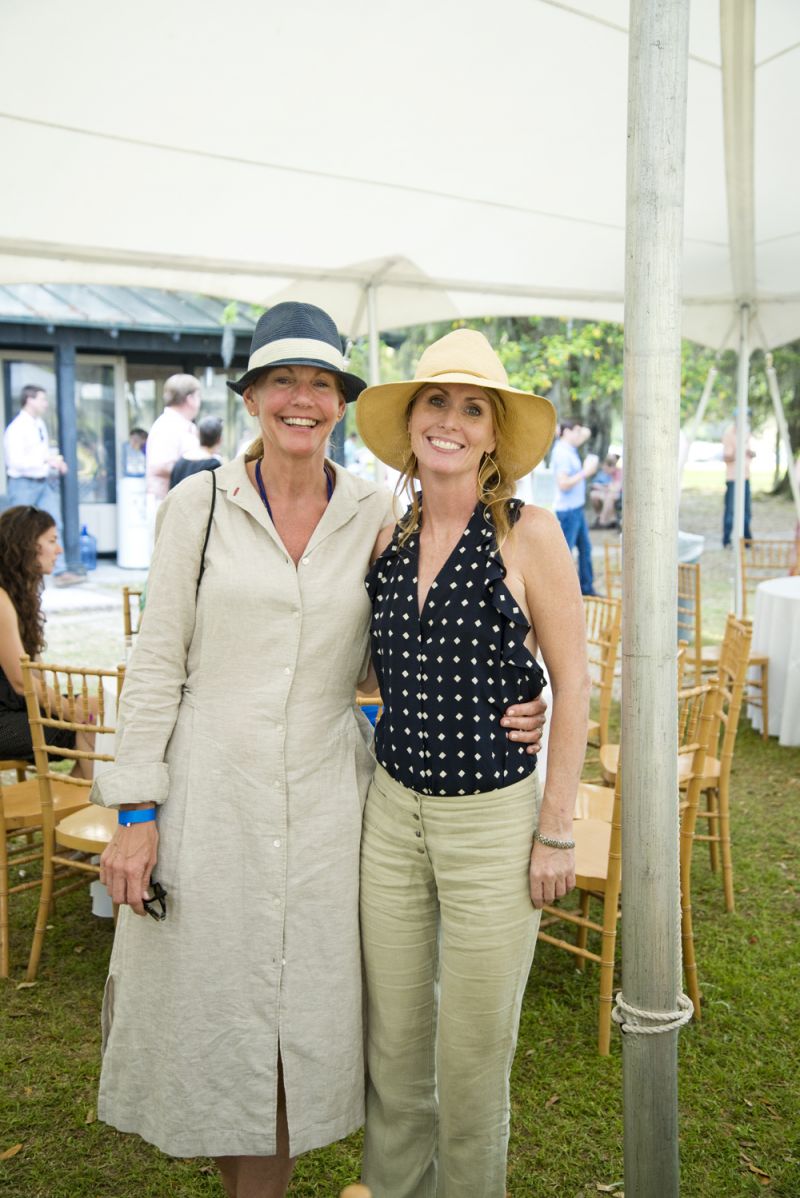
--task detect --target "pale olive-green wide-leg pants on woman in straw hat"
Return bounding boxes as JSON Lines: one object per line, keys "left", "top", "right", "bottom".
{"left": 360, "top": 766, "right": 540, "bottom": 1198}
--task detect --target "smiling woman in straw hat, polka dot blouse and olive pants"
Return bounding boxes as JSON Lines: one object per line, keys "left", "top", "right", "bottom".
{"left": 356, "top": 329, "right": 588, "bottom": 1198}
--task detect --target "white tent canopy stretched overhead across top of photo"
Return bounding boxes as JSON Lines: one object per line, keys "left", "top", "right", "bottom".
{"left": 0, "top": 0, "right": 800, "bottom": 347}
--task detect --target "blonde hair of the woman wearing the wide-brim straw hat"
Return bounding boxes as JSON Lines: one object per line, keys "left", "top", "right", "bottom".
{"left": 395, "top": 383, "right": 516, "bottom": 549}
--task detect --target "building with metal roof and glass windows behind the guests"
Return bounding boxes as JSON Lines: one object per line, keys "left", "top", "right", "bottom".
{"left": 0, "top": 284, "right": 259, "bottom": 565}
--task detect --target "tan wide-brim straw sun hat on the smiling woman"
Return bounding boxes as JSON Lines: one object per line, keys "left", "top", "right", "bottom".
{"left": 356, "top": 328, "right": 556, "bottom": 478}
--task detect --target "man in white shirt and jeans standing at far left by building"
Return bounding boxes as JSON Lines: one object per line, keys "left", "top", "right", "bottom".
{"left": 2, "top": 385, "right": 84, "bottom": 586}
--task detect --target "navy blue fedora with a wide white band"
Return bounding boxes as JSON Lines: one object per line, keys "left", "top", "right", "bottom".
{"left": 228, "top": 301, "right": 366, "bottom": 404}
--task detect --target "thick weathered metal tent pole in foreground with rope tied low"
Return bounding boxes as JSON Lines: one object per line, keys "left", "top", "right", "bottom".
{"left": 616, "top": 0, "right": 689, "bottom": 1198}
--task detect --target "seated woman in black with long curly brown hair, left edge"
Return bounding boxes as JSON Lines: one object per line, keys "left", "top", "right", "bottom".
{"left": 0, "top": 507, "right": 93, "bottom": 778}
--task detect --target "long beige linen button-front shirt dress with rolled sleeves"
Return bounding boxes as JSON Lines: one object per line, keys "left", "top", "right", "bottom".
{"left": 92, "top": 458, "right": 394, "bottom": 1156}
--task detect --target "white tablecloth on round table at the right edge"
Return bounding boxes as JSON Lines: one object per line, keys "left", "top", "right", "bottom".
{"left": 749, "top": 576, "right": 800, "bottom": 745}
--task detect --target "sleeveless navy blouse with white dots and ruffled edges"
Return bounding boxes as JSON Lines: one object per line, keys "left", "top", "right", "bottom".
{"left": 366, "top": 500, "right": 544, "bottom": 794}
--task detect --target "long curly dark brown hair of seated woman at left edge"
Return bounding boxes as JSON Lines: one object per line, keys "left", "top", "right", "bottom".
{"left": 0, "top": 507, "right": 55, "bottom": 658}
